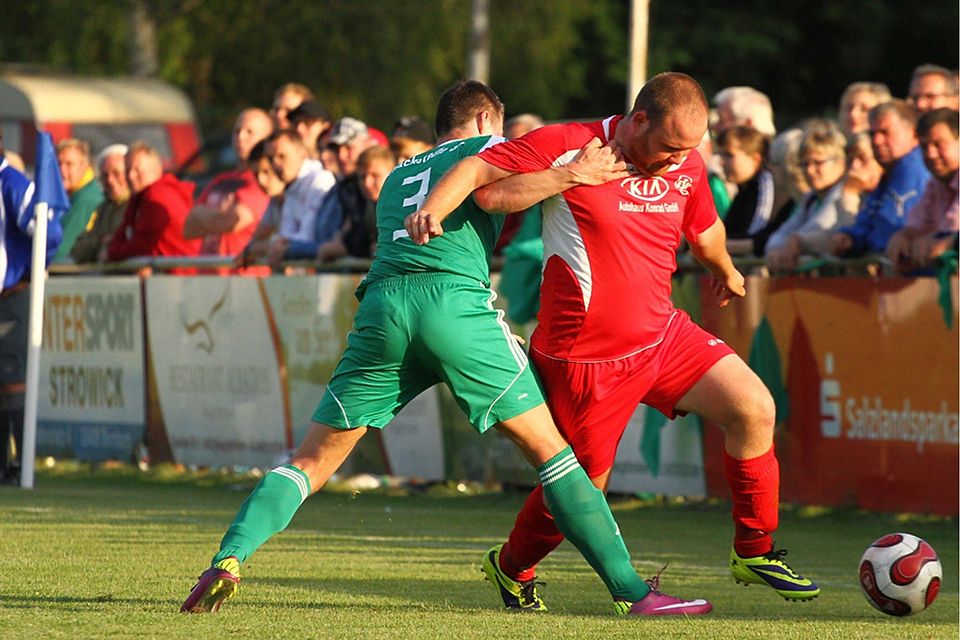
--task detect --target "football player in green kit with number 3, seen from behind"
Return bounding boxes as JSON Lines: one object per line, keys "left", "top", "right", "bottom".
{"left": 181, "top": 81, "right": 711, "bottom": 615}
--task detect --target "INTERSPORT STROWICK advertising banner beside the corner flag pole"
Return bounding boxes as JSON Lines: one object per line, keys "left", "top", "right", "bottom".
{"left": 37, "top": 276, "right": 145, "bottom": 460}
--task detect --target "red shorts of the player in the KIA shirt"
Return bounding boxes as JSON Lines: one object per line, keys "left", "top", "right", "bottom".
{"left": 530, "top": 311, "right": 734, "bottom": 477}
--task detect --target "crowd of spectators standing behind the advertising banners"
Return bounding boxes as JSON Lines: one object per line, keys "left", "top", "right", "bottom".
{"left": 11, "top": 64, "right": 958, "bottom": 274}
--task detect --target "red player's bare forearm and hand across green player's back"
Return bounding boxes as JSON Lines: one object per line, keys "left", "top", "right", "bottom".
{"left": 403, "top": 156, "right": 510, "bottom": 244}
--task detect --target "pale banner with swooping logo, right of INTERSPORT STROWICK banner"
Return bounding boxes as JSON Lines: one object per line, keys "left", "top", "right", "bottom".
{"left": 146, "top": 276, "right": 293, "bottom": 468}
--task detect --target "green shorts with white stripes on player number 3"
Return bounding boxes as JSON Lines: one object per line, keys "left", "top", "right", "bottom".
{"left": 313, "top": 273, "right": 543, "bottom": 433}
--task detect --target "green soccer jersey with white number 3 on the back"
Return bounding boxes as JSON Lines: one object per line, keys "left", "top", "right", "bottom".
{"left": 358, "top": 136, "right": 503, "bottom": 294}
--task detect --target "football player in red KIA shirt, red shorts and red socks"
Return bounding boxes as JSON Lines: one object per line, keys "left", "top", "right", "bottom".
{"left": 405, "top": 73, "right": 820, "bottom": 600}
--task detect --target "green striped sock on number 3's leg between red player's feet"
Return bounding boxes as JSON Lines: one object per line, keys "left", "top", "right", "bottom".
{"left": 537, "top": 447, "right": 650, "bottom": 602}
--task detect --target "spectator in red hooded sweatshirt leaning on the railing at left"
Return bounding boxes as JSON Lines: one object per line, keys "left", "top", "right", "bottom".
{"left": 107, "top": 142, "right": 200, "bottom": 261}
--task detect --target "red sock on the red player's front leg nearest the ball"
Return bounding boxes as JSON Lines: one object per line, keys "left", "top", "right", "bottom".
{"left": 723, "top": 447, "right": 780, "bottom": 558}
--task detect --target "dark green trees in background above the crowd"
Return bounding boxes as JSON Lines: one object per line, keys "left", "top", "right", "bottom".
{"left": 0, "top": 0, "right": 960, "bottom": 136}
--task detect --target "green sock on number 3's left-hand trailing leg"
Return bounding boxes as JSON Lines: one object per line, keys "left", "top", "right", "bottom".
{"left": 213, "top": 464, "right": 310, "bottom": 564}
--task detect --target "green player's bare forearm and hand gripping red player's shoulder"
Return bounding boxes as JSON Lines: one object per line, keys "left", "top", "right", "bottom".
{"left": 473, "top": 138, "right": 630, "bottom": 213}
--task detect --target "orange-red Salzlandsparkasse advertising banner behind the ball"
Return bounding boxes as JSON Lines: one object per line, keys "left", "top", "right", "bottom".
{"left": 703, "top": 278, "right": 960, "bottom": 514}
